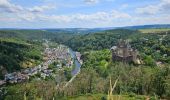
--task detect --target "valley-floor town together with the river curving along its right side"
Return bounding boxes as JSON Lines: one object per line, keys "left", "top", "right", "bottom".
{"left": 0, "top": 40, "right": 83, "bottom": 90}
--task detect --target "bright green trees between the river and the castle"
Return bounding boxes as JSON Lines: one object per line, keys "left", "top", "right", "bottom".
{"left": 82, "top": 50, "right": 111, "bottom": 77}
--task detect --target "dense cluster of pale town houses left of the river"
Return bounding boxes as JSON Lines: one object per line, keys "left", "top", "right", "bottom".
{"left": 0, "top": 45, "right": 73, "bottom": 86}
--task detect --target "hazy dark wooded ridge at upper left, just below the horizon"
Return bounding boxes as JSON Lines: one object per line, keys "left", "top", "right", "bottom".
{"left": 0, "top": 30, "right": 78, "bottom": 44}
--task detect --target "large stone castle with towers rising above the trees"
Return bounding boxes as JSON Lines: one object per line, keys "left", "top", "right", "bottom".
{"left": 111, "top": 40, "right": 138, "bottom": 63}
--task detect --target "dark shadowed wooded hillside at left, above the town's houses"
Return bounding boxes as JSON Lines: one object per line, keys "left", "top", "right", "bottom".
{"left": 0, "top": 38, "right": 42, "bottom": 79}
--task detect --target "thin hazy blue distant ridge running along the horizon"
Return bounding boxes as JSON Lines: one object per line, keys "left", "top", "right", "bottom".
{"left": 0, "top": 24, "right": 170, "bottom": 33}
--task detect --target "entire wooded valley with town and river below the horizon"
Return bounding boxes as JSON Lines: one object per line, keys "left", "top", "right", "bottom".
{"left": 0, "top": 26, "right": 170, "bottom": 100}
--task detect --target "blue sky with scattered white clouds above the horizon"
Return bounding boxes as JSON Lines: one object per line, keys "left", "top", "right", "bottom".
{"left": 0, "top": 0, "right": 170, "bottom": 28}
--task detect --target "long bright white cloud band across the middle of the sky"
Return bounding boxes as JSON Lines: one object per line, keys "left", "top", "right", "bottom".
{"left": 37, "top": 10, "right": 131, "bottom": 23}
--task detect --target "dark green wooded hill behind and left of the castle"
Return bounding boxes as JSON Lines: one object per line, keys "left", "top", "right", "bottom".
{"left": 62, "top": 29, "right": 140, "bottom": 51}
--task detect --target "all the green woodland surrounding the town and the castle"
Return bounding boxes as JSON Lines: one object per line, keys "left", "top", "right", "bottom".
{"left": 0, "top": 29, "right": 170, "bottom": 100}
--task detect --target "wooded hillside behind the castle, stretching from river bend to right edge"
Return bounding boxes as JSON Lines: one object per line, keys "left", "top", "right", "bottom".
{"left": 51, "top": 29, "right": 170, "bottom": 65}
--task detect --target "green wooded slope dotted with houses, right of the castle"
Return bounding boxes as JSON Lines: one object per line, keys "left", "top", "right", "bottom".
{"left": 130, "top": 33, "right": 170, "bottom": 65}
